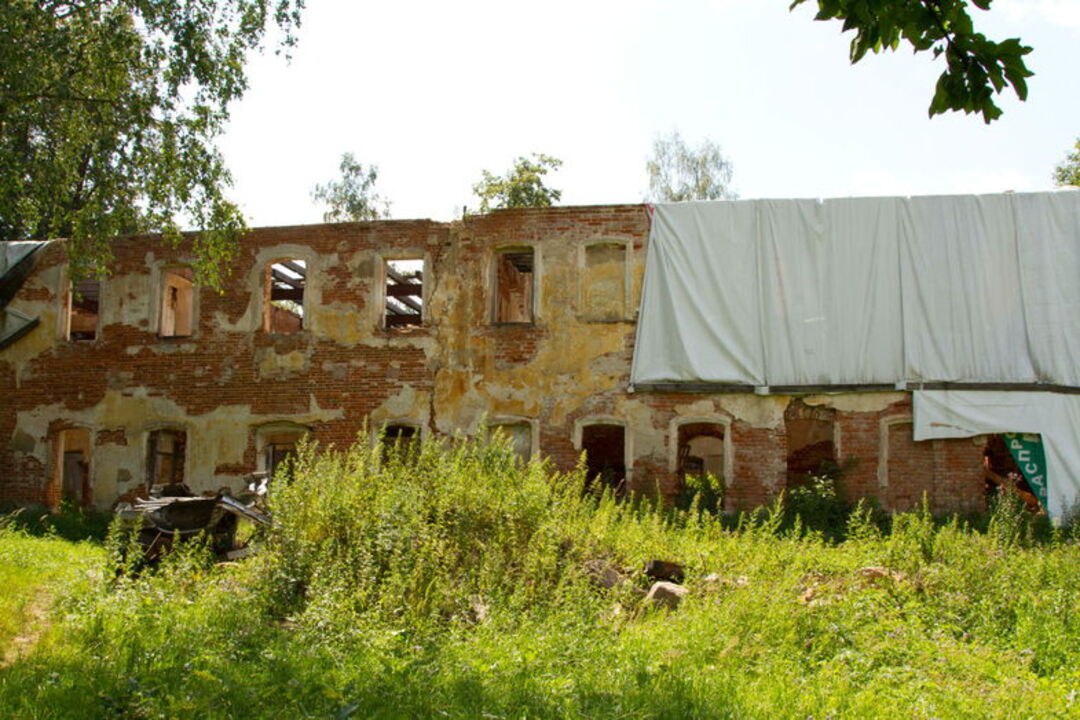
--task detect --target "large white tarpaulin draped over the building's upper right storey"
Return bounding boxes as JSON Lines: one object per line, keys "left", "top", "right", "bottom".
{"left": 632, "top": 191, "right": 1080, "bottom": 386}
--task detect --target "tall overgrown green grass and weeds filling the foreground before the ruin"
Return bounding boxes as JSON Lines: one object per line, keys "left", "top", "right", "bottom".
{"left": 0, "top": 439, "right": 1080, "bottom": 718}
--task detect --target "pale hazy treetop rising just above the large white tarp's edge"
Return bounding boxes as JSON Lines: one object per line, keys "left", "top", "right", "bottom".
{"left": 645, "top": 131, "right": 739, "bottom": 203}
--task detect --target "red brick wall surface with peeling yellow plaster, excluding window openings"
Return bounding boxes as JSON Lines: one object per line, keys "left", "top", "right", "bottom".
{"left": 0, "top": 205, "right": 982, "bottom": 511}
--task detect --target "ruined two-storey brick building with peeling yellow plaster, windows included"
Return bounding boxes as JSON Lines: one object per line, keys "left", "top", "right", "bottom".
{"left": 0, "top": 199, "right": 1049, "bottom": 518}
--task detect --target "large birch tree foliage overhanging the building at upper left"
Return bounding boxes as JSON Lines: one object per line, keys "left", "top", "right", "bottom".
{"left": 0, "top": 0, "right": 303, "bottom": 285}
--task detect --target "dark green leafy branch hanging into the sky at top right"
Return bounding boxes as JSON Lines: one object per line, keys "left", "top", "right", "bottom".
{"left": 791, "top": 0, "right": 1034, "bottom": 123}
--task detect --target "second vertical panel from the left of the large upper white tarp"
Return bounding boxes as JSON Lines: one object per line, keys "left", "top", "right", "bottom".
{"left": 754, "top": 198, "right": 903, "bottom": 385}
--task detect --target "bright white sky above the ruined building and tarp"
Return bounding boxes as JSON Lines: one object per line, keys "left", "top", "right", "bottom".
{"left": 221, "top": 0, "right": 1080, "bottom": 227}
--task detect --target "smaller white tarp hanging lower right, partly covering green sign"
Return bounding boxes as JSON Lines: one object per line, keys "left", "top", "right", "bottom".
{"left": 913, "top": 390, "right": 1080, "bottom": 518}
